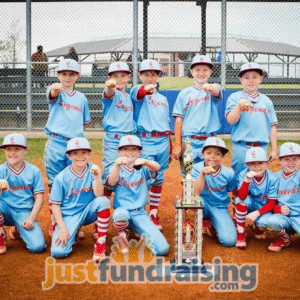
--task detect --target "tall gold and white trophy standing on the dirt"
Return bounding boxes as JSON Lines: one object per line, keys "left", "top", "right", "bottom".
{"left": 173, "top": 138, "right": 203, "bottom": 265}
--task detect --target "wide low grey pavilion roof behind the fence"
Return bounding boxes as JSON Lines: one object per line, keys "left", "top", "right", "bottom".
{"left": 47, "top": 37, "right": 300, "bottom": 57}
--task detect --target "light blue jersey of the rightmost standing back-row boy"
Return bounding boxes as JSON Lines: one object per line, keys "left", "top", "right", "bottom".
{"left": 225, "top": 91, "right": 277, "bottom": 143}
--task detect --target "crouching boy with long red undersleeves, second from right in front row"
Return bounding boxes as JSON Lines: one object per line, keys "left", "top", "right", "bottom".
{"left": 234, "top": 147, "right": 278, "bottom": 249}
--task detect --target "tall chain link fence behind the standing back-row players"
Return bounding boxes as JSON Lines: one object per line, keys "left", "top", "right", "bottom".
{"left": 0, "top": 1, "right": 300, "bottom": 130}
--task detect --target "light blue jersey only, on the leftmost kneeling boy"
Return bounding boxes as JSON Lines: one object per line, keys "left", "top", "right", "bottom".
{"left": 0, "top": 162, "right": 45, "bottom": 210}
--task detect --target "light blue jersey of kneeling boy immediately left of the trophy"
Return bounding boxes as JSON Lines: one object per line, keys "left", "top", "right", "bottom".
{"left": 113, "top": 165, "right": 157, "bottom": 211}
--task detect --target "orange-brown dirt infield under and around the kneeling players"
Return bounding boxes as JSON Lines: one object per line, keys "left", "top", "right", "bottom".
{"left": 0, "top": 151, "right": 300, "bottom": 299}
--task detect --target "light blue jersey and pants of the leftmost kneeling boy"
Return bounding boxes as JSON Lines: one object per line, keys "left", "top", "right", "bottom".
{"left": 0, "top": 162, "right": 46, "bottom": 252}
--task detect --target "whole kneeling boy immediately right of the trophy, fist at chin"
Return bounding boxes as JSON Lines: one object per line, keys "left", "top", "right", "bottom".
{"left": 191, "top": 137, "right": 236, "bottom": 247}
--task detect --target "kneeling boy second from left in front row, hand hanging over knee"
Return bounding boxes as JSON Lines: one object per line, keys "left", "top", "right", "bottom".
{"left": 50, "top": 137, "right": 110, "bottom": 262}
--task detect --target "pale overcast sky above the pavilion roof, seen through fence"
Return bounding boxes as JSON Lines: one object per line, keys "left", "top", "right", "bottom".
{"left": 0, "top": 1, "right": 300, "bottom": 76}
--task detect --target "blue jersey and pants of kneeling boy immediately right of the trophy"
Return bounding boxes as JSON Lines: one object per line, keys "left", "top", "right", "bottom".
{"left": 191, "top": 161, "right": 236, "bottom": 247}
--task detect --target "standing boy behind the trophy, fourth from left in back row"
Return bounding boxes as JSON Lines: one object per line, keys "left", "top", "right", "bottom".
{"left": 173, "top": 55, "right": 222, "bottom": 176}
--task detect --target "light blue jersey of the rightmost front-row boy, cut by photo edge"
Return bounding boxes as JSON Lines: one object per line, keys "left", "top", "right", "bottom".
{"left": 276, "top": 170, "right": 300, "bottom": 216}
